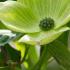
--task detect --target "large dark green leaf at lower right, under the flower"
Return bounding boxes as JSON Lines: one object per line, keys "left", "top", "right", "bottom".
{"left": 46, "top": 32, "right": 70, "bottom": 70}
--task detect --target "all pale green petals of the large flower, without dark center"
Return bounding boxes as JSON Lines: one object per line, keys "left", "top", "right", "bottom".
{"left": 0, "top": 0, "right": 70, "bottom": 44}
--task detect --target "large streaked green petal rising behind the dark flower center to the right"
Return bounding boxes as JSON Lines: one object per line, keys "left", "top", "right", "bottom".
{"left": 18, "top": 0, "right": 70, "bottom": 29}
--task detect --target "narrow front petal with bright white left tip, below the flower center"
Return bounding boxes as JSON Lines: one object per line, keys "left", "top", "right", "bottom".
{"left": 19, "top": 27, "right": 70, "bottom": 45}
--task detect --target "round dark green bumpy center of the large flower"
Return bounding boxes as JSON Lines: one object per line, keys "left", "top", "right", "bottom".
{"left": 39, "top": 18, "right": 54, "bottom": 31}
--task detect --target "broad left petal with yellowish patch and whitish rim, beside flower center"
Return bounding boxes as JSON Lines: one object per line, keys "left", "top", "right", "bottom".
{"left": 0, "top": 1, "right": 40, "bottom": 33}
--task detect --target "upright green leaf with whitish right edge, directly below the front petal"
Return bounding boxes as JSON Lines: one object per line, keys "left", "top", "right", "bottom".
{"left": 23, "top": 45, "right": 40, "bottom": 70}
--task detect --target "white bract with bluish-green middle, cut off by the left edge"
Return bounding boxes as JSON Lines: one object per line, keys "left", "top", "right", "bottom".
{"left": 0, "top": 29, "right": 16, "bottom": 46}
